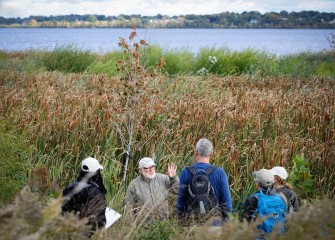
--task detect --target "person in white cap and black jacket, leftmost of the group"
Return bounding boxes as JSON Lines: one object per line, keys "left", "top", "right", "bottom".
{"left": 62, "top": 157, "right": 107, "bottom": 230}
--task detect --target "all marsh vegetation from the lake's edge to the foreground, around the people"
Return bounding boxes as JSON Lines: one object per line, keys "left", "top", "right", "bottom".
{"left": 0, "top": 29, "right": 335, "bottom": 239}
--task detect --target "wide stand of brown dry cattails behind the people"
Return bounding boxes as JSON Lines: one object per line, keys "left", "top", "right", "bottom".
{"left": 0, "top": 70, "right": 335, "bottom": 201}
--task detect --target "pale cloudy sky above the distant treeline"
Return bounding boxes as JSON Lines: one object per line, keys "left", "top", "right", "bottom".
{"left": 0, "top": 0, "right": 335, "bottom": 18}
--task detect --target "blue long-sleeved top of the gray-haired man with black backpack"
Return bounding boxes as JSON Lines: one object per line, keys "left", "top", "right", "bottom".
{"left": 177, "top": 163, "right": 232, "bottom": 214}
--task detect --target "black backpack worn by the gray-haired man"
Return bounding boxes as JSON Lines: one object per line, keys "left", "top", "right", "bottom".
{"left": 186, "top": 166, "right": 217, "bottom": 214}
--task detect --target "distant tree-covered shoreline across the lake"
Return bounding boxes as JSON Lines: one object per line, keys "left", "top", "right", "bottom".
{"left": 0, "top": 11, "right": 335, "bottom": 29}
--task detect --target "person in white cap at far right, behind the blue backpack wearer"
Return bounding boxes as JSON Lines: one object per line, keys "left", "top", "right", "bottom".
{"left": 271, "top": 166, "right": 299, "bottom": 213}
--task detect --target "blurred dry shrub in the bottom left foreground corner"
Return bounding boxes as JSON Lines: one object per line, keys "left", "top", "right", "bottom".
{"left": 0, "top": 187, "right": 89, "bottom": 240}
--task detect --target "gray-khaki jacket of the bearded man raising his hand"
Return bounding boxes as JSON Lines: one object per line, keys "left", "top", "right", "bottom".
{"left": 124, "top": 173, "right": 179, "bottom": 215}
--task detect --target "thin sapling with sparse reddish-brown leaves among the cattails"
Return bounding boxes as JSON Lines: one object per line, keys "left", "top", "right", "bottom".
{"left": 105, "top": 27, "right": 164, "bottom": 181}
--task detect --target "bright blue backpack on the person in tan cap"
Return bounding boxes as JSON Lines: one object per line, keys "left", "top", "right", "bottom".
{"left": 253, "top": 191, "right": 287, "bottom": 233}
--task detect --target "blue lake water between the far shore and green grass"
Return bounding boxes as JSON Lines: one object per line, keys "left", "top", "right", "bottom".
{"left": 0, "top": 28, "right": 335, "bottom": 56}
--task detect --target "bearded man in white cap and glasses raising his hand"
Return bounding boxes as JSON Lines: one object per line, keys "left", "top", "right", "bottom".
{"left": 124, "top": 157, "right": 179, "bottom": 216}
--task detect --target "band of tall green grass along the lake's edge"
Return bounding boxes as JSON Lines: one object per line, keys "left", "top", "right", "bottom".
{"left": 0, "top": 45, "right": 335, "bottom": 79}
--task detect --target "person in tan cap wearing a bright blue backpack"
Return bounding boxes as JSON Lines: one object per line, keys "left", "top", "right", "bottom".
{"left": 242, "top": 169, "right": 287, "bottom": 233}
